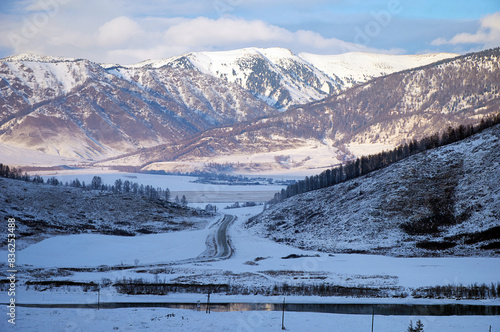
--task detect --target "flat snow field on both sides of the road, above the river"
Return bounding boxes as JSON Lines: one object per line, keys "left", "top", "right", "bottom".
{"left": 2, "top": 204, "right": 500, "bottom": 288}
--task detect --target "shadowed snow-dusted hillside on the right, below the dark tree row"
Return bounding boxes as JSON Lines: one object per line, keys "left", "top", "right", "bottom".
{"left": 247, "top": 125, "right": 500, "bottom": 256}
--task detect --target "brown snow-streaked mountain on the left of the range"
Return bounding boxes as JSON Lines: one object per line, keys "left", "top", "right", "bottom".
{"left": 0, "top": 55, "right": 277, "bottom": 158}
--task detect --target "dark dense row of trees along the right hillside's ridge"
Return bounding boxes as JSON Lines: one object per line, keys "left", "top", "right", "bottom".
{"left": 270, "top": 113, "right": 500, "bottom": 204}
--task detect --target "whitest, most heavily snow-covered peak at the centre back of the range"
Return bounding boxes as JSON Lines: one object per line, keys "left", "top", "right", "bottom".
{"left": 128, "top": 48, "right": 458, "bottom": 109}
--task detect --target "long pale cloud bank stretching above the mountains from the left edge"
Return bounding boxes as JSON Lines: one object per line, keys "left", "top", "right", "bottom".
{"left": 0, "top": 6, "right": 397, "bottom": 64}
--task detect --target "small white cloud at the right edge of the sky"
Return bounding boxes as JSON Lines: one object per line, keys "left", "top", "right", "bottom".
{"left": 431, "top": 12, "right": 500, "bottom": 48}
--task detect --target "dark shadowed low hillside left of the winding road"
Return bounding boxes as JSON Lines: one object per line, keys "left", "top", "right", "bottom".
{"left": 0, "top": 178, "right": 213, "bottom": 249}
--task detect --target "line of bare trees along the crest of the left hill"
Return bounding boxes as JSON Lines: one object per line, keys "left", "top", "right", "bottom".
{"left": 0, "top": 163, "right": 188, "bottom": 206}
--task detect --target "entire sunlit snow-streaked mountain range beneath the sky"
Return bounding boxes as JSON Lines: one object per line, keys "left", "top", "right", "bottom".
{"left": 0, "top": 48, "right": 500, "bottom": 174}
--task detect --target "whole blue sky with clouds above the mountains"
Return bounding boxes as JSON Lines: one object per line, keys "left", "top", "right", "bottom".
{"left": 0, "top": 0, "right": 500, "bottom": 64}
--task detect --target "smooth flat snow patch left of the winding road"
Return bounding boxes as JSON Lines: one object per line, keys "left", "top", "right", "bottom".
{"left": 18, "top": 231, "right": 207, "bottom": 268}
